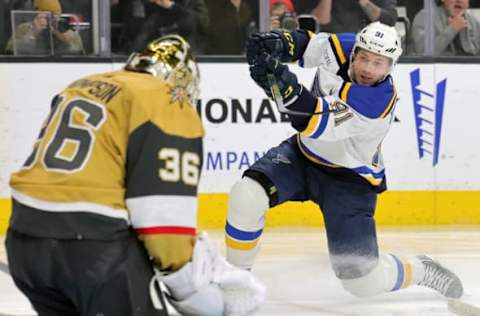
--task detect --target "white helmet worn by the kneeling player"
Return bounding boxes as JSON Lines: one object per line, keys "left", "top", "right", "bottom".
{"left": 350, "top": 21, "right": 402, "bottom": 73}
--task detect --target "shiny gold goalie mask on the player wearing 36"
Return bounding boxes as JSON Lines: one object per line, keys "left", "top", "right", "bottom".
{"left": 125, "top": 35, "right": 200, "bottom": 103}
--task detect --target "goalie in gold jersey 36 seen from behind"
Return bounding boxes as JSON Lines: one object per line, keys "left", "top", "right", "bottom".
{"left": 6, "top": 35, "right": 264, "bottom": 316}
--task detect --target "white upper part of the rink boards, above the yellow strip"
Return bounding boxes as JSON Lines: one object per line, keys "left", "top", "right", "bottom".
{"left": 0, "top": 63, "right": 480, "bottom": 197}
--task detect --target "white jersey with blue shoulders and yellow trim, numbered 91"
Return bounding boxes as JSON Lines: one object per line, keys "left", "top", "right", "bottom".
{"left": 297, "top": 33, "right": 397, "bottom": 186}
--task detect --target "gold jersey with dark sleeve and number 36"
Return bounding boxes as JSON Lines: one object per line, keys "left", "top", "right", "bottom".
{"left": 10, "top": 70, "right": 203, "bottom": 268}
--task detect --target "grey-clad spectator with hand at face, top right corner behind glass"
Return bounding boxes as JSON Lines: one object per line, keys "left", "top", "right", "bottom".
{"left": 410, "top": 0, "right": 480, "bottom": 56}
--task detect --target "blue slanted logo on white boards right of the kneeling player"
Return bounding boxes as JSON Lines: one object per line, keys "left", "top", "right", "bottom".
{"left": 410, "top": 69, "right": 447, "bottom": 166}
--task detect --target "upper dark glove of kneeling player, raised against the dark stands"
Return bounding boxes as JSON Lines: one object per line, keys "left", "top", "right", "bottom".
{"left": 247, "top": 30, "right": 298, "bottom": 65}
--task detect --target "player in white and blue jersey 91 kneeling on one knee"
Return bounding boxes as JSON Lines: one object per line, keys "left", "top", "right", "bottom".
{"left": 225, "top": 22, "right": 463, "bottom": 298}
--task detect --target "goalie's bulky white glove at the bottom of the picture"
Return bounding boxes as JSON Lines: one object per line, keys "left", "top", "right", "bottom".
{"left": 154, "top": 233, "right": 266, "bottom": 316}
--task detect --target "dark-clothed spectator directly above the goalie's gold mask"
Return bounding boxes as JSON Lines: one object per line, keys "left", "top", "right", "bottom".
{"left": 133, "top": 0, "right": 209, "bottom": 54}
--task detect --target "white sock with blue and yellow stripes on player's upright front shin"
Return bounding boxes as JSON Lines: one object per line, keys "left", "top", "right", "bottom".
{"left": 225, "top": 177, "right": 269, "bottom": 269}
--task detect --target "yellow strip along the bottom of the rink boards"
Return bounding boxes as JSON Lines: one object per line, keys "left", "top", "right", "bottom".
{"left": 0, "top": 191, "right": 480, "bottom": 234}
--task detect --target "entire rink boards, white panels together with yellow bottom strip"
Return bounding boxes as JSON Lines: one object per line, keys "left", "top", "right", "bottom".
{"left": 0, "top": 63, "right": 480, "bottom": 230}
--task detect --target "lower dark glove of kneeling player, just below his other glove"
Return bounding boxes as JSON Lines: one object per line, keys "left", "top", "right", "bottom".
{"left": 250, "top": 53, "right": 302, "bottom": 103}
